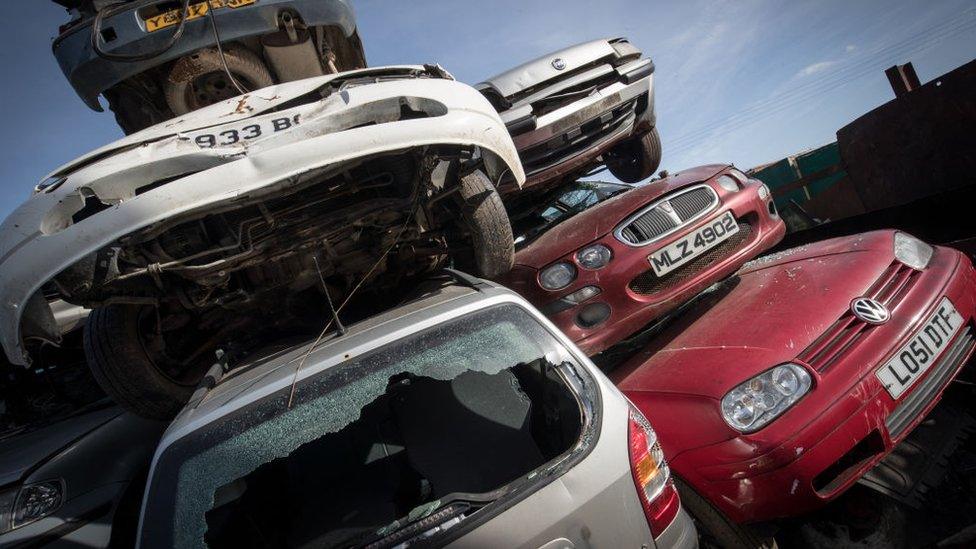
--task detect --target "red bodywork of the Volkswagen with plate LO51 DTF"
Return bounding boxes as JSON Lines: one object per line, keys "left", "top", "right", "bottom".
{"left": 612, "top": 231, "right": 976, "bottom": 523}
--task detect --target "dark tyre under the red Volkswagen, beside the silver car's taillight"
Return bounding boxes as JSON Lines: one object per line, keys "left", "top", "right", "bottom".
{"left": 674, "top": 476, "right": 777, "bottom": 549}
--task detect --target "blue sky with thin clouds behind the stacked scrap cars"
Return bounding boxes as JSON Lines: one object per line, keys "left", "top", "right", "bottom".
{"left": 0, "top": 0, "right": 976, "bottom": 218}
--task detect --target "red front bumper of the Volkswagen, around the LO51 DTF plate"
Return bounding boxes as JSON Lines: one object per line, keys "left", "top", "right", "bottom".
{"left": 670, "top": 248, "right": 976, "bottom": 523}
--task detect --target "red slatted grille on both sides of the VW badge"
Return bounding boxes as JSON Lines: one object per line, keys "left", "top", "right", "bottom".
{"left": 797, "top": 261, "right": 921, "bottom": 372}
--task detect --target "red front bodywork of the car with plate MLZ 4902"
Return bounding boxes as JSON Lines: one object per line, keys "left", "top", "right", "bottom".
{"left": 499, "top": 165, "right": 786, "bottom": 354}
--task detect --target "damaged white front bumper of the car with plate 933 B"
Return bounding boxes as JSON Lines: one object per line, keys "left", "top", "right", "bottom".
{"left": 0, "top": 74, "right": 525, "bottom": 364}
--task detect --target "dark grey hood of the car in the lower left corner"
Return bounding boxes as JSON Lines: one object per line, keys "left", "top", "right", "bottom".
{"left": 0, "top": 406, "right": 122, "bottom": 486}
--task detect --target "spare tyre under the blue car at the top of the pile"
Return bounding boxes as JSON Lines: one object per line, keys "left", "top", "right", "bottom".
{"left": 164, "top": 47, "right": 274, "bottom": 116}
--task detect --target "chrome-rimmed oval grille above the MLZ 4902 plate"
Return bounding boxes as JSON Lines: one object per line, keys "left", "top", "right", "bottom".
{"left": 614, "top": 185, "right": 718, "bottom": 246}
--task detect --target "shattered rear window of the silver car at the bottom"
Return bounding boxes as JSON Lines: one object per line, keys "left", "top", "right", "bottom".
{"left": 141, "top": 305, "right": 585, "bottom": 547}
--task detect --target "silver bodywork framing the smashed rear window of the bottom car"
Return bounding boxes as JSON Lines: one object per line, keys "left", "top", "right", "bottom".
{"left": 140, "top": 283, "right": 697, "bottom": 547}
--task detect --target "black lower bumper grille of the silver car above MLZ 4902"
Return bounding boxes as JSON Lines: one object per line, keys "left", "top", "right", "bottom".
{"left": 519, "top": 98, "right": 637, "bottom": 175}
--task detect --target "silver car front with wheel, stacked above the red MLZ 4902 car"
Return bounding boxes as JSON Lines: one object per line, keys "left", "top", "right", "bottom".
{"left": 475, "top": 38, "right": 661, "bottom": 190}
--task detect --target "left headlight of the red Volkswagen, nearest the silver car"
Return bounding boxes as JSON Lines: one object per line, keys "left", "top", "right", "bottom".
{"left": 722, "top": 363, "right": 811, "bottom": 433}
